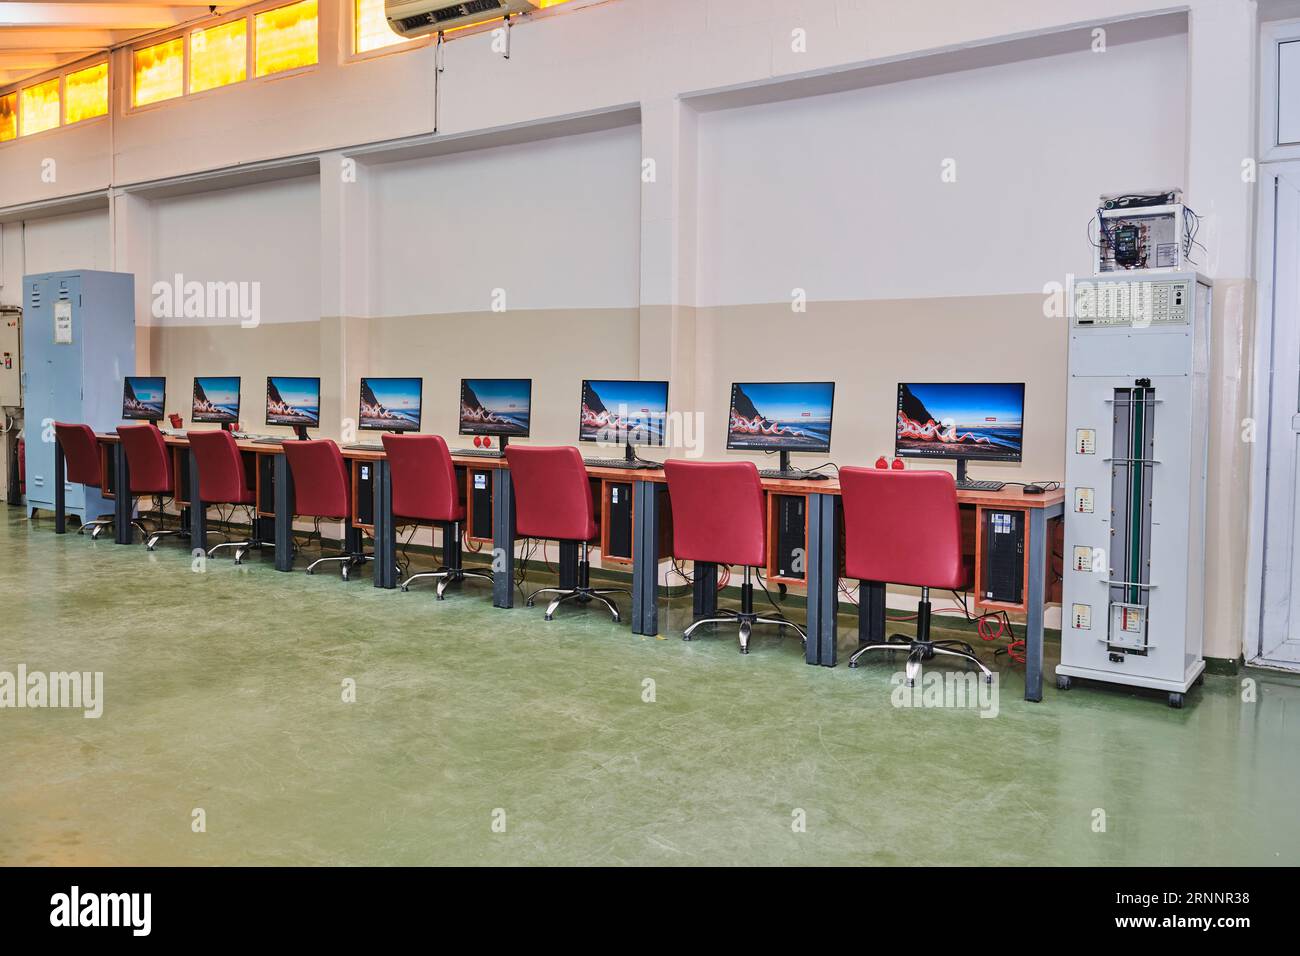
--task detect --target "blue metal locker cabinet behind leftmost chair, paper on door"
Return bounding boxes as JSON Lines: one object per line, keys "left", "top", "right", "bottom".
{"left": 22, "top": 269, "right": 135, "bottom": 522}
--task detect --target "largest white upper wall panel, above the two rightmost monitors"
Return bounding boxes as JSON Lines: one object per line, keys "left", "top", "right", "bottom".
{"left": 697, "top": 36, "right": 1187, "bottom": 306}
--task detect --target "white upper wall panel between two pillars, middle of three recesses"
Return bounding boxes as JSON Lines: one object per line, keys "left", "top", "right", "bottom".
{"left": 371, "top": 126, "right": 641, "bottom": 316}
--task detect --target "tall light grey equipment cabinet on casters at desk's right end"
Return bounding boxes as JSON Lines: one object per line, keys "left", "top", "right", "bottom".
{"left": 1057, "top": 272, "right": 1210, "bottom": 706}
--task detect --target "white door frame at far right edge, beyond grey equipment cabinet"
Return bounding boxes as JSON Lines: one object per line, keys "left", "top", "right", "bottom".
{"left": 1243, "top": 160, "right": 1300, "bottom": 670}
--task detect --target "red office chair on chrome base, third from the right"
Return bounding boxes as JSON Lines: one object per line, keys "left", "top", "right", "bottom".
{"left": 506, "top": 445, "right": 632, "bottom": 622}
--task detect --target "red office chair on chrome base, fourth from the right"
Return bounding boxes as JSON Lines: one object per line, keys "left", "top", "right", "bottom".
{"left": 381, "top": 433, "right": 493, "bottom": 601}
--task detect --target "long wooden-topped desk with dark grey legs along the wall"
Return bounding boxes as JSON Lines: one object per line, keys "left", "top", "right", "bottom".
{"left": 76, "top": 433, "right": 1065, "bottom": 701}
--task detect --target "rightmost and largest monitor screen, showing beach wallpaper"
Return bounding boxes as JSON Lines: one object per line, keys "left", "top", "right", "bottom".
{"left": 894, "top": 382, "right": 1024, "bottom": 462}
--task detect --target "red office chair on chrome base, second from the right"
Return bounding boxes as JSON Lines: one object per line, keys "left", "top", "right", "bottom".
{"left": 663, "top": 460, "right": 807, "bottom": 654}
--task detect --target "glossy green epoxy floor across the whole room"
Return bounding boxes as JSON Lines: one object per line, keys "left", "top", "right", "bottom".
{"left": 0, "top": 509, "right": 1300, "bottom": 865}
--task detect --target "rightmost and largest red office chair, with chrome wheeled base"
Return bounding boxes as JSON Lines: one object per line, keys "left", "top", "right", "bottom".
{"left": 840, "top": 466, "right": 993, "bottom": 687}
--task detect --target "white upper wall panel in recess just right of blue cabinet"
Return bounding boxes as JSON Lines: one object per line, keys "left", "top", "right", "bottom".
{"left": 139, "top": 176, "right": 321, "bottom": 325}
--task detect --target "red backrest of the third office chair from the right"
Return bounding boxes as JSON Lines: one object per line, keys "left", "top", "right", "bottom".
{"left": 506, "top": 445, "right": 595, "bottom": 541}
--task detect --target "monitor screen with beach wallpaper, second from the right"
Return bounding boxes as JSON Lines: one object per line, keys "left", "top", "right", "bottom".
{"left": 727, "top": 381, "right": 835, "bottom": 451}
